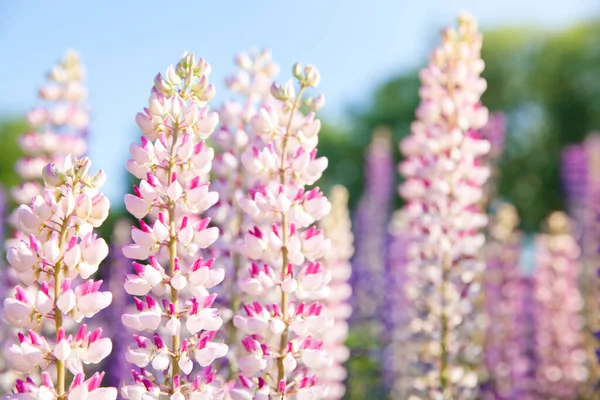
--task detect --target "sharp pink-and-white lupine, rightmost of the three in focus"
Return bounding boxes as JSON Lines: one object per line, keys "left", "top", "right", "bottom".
{"left": 229, "top": 64, "right": 333, "bottom": 399}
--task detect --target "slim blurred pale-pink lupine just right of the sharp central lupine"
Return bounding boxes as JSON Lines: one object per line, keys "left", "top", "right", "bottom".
{"left": 318, "top": 186, "right": 354, "bottom": 400}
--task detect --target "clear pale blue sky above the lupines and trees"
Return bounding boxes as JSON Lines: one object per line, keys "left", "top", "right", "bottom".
{"left": 0, "top": 0, "right": 600, "bottom": 201}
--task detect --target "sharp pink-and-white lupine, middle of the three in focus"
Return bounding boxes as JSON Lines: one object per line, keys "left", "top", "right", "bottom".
{"left": 121, "top": 53, "right": 227, "bottom": 400}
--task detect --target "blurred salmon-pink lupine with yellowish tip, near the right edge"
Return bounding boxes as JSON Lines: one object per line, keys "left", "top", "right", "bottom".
{"left": 533, "top": 212, "right": 589, "bottom": 400}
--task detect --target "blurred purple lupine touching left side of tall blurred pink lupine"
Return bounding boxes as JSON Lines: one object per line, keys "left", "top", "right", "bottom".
{"left": 382, "top": 210, "right": 410, "bottom": 399}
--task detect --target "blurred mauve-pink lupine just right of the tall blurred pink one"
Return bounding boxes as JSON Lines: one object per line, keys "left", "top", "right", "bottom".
{"left": 483, "top": 204, "right": 527, "bottom": 400}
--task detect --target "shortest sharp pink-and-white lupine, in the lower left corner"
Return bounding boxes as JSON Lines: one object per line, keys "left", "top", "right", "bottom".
{"left": 3, "top": 156, "right": 117, "bottom": 399}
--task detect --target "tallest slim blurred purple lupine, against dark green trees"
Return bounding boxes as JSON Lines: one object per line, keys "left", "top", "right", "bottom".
{"left": 352, "top": 128, "right": 394, "bottom": 335}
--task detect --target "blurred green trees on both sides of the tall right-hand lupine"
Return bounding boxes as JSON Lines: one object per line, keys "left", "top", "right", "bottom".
{"left": 320, "top": 21, "right": 600, "bottom": 231}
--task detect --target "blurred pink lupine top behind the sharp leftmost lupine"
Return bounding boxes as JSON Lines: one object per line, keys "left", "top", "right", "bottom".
{"left": 11, "top": 50, "right": 89, "bottom": 204}
